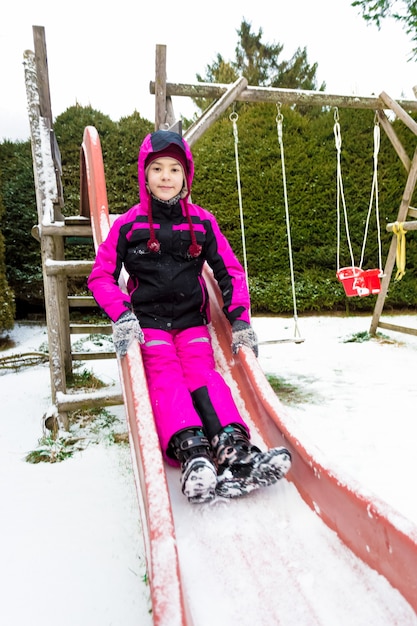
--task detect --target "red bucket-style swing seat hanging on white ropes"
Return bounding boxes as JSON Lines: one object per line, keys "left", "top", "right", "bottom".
{"left": 333, "top": 107, "right": 384, "bottom": 297}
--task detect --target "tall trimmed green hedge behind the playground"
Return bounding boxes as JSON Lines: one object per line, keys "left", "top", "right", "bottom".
{"left": 0, "top": 104, "right": 417, "bottom": 314}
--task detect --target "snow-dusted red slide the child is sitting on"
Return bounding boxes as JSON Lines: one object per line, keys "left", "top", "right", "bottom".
{"left": 81, "top": 127, "right": 417, "bottom": 626}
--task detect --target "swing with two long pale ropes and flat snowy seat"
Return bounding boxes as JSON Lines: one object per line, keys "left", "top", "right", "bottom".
{"left": 229, "top": 102, "right": 304, "bottom": 344}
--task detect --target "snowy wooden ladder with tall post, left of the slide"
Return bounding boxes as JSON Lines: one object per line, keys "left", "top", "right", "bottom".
{"left": 24, "top": 26, "right": 123, "bottom": 429}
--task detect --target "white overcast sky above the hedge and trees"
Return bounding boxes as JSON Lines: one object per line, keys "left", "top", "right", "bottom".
{"left": 0, "top": 0, "right": 417, "bottom": 141}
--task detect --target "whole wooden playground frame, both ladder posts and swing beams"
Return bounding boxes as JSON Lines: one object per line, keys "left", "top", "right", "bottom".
{"left": 24, "top": 26, "right": 417, "bottom": 427}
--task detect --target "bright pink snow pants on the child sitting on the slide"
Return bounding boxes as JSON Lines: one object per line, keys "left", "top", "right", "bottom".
{"left": 141, "top": 326, "right": 249, "bottom": 465}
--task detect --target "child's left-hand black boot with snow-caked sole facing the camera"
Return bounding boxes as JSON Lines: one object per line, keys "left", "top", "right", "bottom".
{"left": 169, "top": 428, "right": 217, "bottom": 504}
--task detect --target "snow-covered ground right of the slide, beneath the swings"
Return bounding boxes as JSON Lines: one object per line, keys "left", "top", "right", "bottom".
{"left": 255, "top": 315, "right": 417, "bottom": 523}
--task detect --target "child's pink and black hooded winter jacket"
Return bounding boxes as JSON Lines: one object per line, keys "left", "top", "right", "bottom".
{"left": 88, "top": 130, "right": 250, "bottom": 330}
